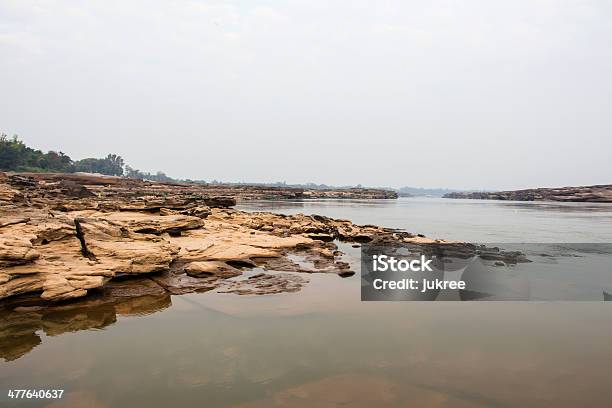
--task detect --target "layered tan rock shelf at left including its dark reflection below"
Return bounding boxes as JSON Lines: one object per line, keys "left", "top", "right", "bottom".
{"left": 0, "top": 173, "right": 532, "bottom": 360}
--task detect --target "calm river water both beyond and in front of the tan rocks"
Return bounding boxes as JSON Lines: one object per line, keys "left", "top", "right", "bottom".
{"left": 0, "top": 198, "right": 612, "bottom": 408}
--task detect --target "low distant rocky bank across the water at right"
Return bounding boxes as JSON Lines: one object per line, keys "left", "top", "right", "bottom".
{"left": 443, "top": 184, "right": 612, "bottom": 203}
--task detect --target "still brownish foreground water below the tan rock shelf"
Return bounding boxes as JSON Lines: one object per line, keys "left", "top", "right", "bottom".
{"left": 0, "top": 292, "right": 612, "bottom": 408}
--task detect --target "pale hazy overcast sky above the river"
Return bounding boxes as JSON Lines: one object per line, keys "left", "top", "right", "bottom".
{"left": 0, "top": 0, "right": 612, "bottom": 190}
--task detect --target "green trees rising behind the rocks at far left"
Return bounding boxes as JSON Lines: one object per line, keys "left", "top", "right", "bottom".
{"left": 0, "top": 133, "right": 177, "bottom": 181}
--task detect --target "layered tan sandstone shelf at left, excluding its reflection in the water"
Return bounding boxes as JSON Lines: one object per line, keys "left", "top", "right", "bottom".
{"left": 0, "top": 173, "right": 424, "bottom": 302}
